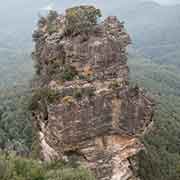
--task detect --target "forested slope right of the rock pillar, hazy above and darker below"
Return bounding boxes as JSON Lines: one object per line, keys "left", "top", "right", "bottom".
{"left": 129, "top": 55, "right": 180, "bottom": 180}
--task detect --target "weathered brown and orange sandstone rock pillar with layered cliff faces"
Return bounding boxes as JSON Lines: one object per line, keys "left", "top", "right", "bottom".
{"left": 33, "top": 6, "right": 153, "bottom": 180}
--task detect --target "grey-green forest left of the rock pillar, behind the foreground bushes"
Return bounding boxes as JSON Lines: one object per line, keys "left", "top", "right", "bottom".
{"left": 0, "top": 87, "right": 33, "bottom": 154}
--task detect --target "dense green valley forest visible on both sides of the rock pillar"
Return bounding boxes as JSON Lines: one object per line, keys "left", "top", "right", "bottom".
{"left": 0, "top": 53, "right": 180, "bottom": 180}
